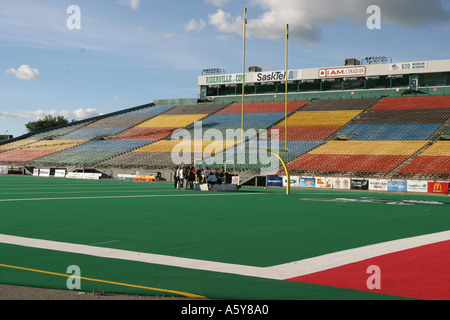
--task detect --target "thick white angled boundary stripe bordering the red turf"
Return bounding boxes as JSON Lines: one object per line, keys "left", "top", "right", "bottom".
{"left": 0, "top": 231, "right": 450, "bottom": 280}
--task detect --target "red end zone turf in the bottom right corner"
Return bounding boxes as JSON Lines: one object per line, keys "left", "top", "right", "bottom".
{"left": 287, "top": 241, "right": 450, "bottom": 300}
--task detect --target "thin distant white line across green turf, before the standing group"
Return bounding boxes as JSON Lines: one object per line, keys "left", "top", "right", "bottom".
{"left": 0, "top": 192, "right": 267, "bottom": 202}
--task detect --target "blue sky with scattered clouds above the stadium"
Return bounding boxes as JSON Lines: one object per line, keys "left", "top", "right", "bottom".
{"left": 0, "top": 0, "right": 450, "bottom": 136}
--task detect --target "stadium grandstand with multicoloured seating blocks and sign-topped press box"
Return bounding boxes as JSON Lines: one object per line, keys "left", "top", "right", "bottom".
{"left": 0, "top": 59, "right": 450, "bottom": 189}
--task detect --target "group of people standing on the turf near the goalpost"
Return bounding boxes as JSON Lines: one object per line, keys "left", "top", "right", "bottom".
{"left": 174, "top": 166, "right": 231, "bottom": 190}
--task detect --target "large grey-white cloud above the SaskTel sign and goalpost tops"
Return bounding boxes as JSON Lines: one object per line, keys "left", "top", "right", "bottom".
{"left": 208, "top": 0, "right": 450, "bottom": 43}
